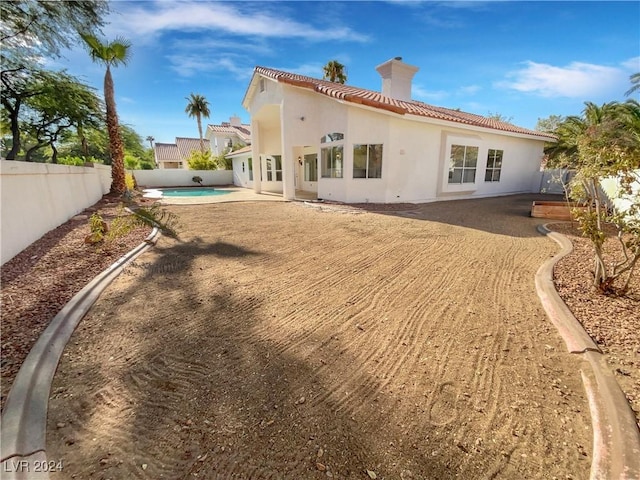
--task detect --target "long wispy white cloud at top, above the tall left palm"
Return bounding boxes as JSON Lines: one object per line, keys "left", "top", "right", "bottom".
{"left": 107, "top": 1, "right": 367, "bottom": 42}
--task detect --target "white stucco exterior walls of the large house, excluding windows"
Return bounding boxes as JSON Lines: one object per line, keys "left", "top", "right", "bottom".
{"left": 248, "top": 74, "right": 544, "bottom": 203}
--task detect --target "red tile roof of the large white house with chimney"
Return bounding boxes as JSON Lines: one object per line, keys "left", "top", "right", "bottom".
{"left": 255, "top": 67, "right": 555, "bottom": 140}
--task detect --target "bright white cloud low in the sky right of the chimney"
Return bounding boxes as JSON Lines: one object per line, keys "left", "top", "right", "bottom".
{"left": 496, "top": 61, "right": 629, "bottom": 98}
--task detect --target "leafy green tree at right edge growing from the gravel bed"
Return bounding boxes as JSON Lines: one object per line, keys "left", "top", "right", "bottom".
{"left": 545, "top": 100, "right": 640, "bottom": 293}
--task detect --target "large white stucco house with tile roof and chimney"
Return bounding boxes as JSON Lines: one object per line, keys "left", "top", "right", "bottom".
{"left": 240, "top": 57, "right": 553, "bottom": 203}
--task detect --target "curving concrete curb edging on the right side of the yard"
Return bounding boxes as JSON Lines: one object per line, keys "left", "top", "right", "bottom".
{"left": 535, "top": 224, "right": 640, "bottom": 480}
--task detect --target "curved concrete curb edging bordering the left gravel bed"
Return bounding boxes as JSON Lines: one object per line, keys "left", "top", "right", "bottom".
{"left": 0, "top": 228, "right": 160, "bottom": 480}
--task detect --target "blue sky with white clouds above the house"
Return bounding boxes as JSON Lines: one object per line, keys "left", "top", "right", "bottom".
{"left": 52, "top": 0, "right": 640, "bottom": 143}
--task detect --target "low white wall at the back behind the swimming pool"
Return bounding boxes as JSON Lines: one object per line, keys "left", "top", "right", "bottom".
{"left": 130, "top": 169, "right": 233, "bottom": 187}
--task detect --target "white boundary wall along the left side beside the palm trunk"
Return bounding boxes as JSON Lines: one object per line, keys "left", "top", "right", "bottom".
{"left": 0, "top": 160, "right": 111, "bottom": 264}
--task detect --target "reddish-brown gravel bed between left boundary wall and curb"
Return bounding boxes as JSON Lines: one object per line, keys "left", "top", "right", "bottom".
{"left": 0, "top": 195, "right": 151, "bottom": 409}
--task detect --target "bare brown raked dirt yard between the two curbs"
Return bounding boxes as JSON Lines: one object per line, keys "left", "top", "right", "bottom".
{"left": 47, "top": 196, "right": 592, "bottom": 480}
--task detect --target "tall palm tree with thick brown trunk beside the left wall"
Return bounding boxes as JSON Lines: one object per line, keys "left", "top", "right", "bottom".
{"left": 81, "top": 33, "right": 131, "bottom": 194}
